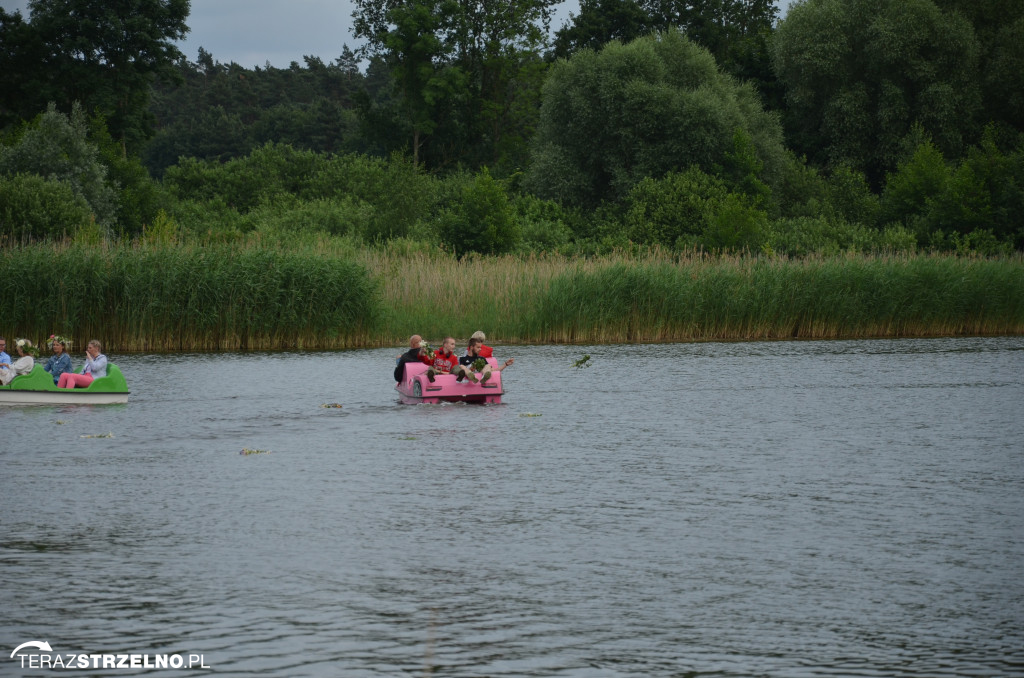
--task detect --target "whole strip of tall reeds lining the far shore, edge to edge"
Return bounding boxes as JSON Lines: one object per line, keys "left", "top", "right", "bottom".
{"left": 0, "top": 239, "right": 1024, "bottom": 351}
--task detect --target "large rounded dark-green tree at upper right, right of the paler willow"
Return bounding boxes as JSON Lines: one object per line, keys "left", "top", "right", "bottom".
{"left": 772, "top": 0, "right": 981, "bottom": 185}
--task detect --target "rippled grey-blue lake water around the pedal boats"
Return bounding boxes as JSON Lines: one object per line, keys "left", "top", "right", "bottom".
{"left": 0, "top": 338, "right": 1024, "bottom": 678}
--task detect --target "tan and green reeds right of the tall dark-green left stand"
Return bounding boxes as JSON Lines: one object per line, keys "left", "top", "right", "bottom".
{"left": 361, "top": 250, "right": 1024, "bottom": 343}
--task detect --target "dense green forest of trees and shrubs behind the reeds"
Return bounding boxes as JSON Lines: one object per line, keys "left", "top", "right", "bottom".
{"left": 0, "top": 0, "right": 1024, "bottom": 256}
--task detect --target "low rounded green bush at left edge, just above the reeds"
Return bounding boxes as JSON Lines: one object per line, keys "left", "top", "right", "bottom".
{"left": 0, "top": 174, "right": 92, "bottom": 247}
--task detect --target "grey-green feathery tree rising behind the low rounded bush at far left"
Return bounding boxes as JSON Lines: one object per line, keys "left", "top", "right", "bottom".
{"left": 0, "top": 104, "right": 118, "bottom": 228}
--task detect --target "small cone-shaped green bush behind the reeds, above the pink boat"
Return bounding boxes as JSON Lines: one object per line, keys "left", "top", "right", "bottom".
{"left": 441, "top": 168, "right": 521, "bottom": 256}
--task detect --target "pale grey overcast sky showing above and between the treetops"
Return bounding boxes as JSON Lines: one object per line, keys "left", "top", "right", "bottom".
{"left": 0, "top": 0, "right": 790, "bottom": 69}
